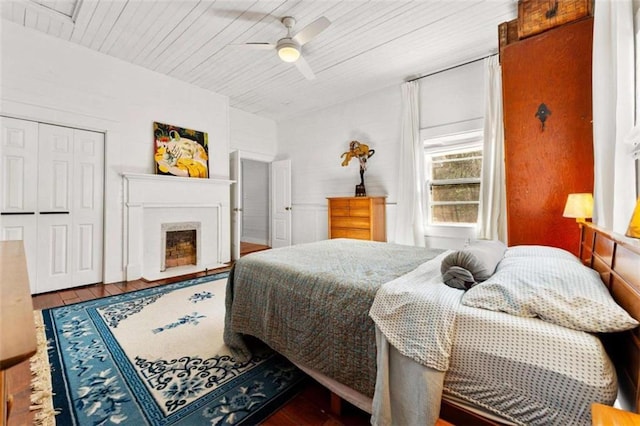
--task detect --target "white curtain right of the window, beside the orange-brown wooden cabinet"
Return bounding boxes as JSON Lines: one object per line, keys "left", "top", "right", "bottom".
{"left": 478, "top": 56, "right": 507, "bottom": 243}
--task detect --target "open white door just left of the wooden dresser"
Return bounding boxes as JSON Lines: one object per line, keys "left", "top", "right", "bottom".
{"left": 270, "top": 160, "right": 291, "bottom": 248}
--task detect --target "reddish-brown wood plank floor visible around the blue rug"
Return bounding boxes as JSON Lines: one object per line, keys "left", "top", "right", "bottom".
{"left": 7, "top": 244, "right": 369, "bottom": 426}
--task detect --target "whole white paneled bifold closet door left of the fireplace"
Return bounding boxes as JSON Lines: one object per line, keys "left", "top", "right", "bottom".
{"left": 0, "top": 117, "right": 104, "bottom": 293}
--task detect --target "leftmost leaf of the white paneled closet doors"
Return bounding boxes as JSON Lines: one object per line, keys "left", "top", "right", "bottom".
{"left": 0, "top": 117, "right": 38, "bottom": 293}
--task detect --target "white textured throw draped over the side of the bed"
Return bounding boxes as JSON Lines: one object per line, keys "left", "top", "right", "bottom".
{"left": 369, "top": 252, "right": 463, "bottom": 426}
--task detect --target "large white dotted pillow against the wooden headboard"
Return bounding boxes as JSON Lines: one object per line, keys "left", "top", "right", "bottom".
{"left": 462, "top": 257, "right": 638, "bottom": 333}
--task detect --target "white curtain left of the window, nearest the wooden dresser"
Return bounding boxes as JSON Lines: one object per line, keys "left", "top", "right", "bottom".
{"left": 395, "top": 81, "right": 425, "bottom": 247}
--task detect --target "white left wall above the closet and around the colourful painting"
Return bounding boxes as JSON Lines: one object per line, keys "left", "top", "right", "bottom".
{"left": 0, "top": 20, "right": 230, "bottom": 282}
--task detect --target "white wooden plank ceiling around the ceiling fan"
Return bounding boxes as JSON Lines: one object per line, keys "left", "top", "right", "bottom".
{"left": 0, "top": 0, "right": 517, "bottom": 120}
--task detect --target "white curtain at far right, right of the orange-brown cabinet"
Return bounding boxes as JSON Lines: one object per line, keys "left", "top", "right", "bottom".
{"left": 593, "top": 0, "right": 636, "bottom": 233}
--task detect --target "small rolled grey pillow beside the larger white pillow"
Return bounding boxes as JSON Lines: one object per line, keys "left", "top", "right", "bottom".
{"left": 440, "top": 240, "right": 507, "bottom": 290}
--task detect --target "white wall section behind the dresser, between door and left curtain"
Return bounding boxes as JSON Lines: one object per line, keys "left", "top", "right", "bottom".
{"left": 278, "top": 87, "right": 400, "bottom": 244}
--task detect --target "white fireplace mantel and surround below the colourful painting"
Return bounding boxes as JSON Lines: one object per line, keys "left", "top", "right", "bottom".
{"left": 122, "top": 173, "right": 234, "bottom": 281}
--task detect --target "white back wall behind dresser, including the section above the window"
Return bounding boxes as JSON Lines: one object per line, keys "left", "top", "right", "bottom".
{"left": 278, "top": 61, "right": 484, "bottom": 246}
